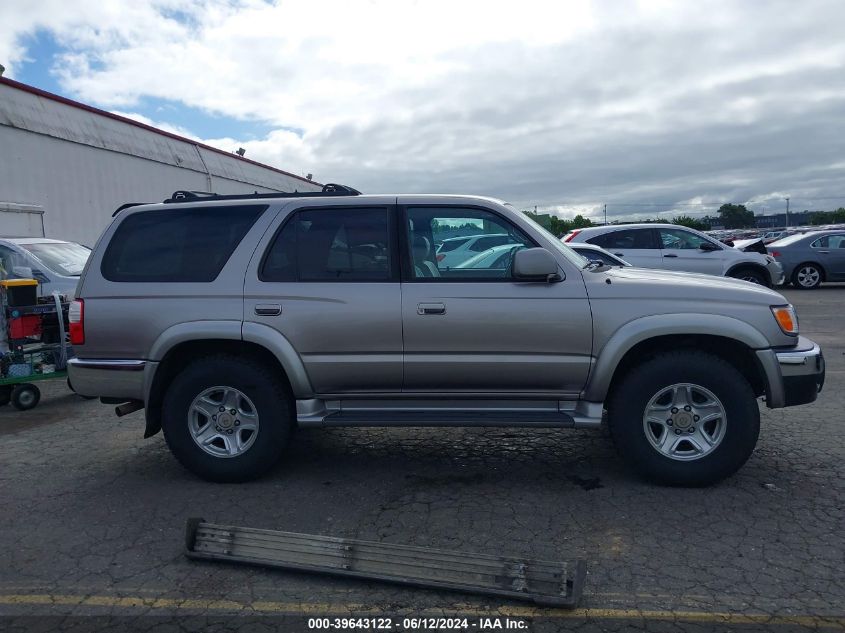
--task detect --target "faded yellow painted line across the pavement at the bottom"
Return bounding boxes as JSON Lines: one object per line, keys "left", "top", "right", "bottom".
{"left": 0, "top": 594, "right": 845, "bottom": 631}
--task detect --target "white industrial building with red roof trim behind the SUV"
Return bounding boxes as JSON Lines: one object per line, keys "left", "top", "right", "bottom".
{"left": 0, "top": 77, "right": 321, "bottom": 246}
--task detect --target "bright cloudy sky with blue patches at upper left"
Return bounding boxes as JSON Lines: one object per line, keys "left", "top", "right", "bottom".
{"left": 0, "top": 0, "right": 845, "bottom": 219}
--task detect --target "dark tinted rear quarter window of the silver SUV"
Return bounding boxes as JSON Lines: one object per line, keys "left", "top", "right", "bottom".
{"left": 100, "top": 205, "right": 267, "bottom": 283}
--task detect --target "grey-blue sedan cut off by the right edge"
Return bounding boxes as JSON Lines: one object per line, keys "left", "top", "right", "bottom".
{"left": 769, "top": 229, "right": 845, "bottom": 290}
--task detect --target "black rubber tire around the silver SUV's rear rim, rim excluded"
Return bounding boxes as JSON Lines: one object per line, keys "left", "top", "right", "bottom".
{"left": 162, "top": 354, "right": 294, "bottom": 483}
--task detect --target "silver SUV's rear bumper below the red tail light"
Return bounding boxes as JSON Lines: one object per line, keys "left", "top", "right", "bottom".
{"left": 68, "top": 358, "right": 149, "bottom": 400}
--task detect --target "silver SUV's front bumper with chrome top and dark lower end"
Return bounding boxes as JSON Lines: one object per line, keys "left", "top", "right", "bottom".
{"left": 757, "top": 336, "right": 825, "bottom": 409}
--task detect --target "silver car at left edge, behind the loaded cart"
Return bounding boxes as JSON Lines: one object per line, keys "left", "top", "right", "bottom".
{"left": 0, "top": 237, "right": 91, "bottom": 299}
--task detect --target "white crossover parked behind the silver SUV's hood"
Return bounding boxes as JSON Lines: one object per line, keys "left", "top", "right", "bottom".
{"left": 564, "top": 223, "right": 783, "bottom": 288}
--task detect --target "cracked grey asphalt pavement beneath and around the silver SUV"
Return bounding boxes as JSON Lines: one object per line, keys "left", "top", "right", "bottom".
{"left": 0, "top": 284, "right": 845, "bottom": 631}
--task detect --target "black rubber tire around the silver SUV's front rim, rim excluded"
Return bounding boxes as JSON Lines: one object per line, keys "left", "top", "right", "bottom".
{"left": 608, "top": 351, "right": 760, "bottom": 486}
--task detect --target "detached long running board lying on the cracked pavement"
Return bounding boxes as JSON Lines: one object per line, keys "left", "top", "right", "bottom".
{"left": 185, "top": 519, "right": 586, "bottom": 608}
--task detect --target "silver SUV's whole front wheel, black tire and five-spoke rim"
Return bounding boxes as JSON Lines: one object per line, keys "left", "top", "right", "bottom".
{"left": 608, "top": 351, "right": 760, "bottom": 486}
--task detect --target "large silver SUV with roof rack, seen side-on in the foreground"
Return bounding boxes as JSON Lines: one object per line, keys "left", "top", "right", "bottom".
{"left": 70, "top": 186, "right": 824, "bottom": 485}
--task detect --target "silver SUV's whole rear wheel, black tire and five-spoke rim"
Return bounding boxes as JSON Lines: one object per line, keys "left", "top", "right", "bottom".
{"left": 162, "top": 354, "right": 293, "bottom": 482}
